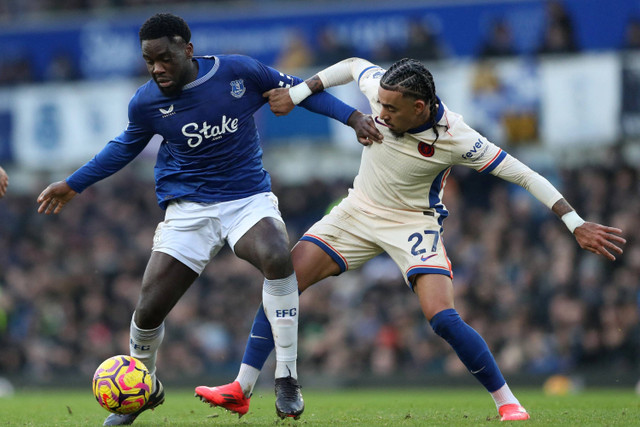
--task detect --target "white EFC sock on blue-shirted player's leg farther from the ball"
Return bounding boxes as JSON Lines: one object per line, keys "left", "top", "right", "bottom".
{"left": 262, "top": 273, "right": 299, "bottom": 378}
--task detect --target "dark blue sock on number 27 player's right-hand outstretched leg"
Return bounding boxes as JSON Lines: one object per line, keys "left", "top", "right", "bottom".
{"left": 430, "top": 308, "right": 506, "bottom": 393}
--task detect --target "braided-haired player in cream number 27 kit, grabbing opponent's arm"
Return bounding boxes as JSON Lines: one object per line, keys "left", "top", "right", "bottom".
{"left": 199, "top": 58, "right": 625, "bottom": 421}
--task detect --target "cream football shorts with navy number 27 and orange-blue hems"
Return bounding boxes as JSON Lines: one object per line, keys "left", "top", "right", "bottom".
{"left": 300, "top": 198, "right": 453, "bottom": 288}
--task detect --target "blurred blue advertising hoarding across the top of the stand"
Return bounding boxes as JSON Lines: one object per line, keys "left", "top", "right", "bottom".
{"left": 0, "top": 0, "right": 640, "bottom": 80}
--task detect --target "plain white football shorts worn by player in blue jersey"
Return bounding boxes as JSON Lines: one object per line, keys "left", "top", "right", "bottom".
{"left": 152, "top": 192, "right": 284, "bottom": 274}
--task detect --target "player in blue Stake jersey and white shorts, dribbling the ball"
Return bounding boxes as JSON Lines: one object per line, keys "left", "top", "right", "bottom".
{"left": 37, "top": 13, "right": 377, "bottom": 425}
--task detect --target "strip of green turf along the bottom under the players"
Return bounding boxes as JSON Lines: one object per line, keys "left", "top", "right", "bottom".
{"left": 0, "top": 388, "right": 640, "bottom": 427}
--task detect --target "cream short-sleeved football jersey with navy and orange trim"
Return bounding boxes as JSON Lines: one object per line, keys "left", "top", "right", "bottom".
{"left": 350, "top": 66, "right": 507, "bottom": 217}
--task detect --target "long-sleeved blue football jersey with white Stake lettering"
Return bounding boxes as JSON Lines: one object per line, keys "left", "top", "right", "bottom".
{"left": 67, "top": 55, "right": 354, "bottom": 209}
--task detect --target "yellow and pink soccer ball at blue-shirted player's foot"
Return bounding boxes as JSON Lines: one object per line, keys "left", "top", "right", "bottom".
{"left": 93, "top": 355, "right": 151, "bottom": 414}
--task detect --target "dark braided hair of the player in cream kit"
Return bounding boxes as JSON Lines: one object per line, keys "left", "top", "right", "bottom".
{"left": 380, "top": 58, "right": 439, "bottom": 141}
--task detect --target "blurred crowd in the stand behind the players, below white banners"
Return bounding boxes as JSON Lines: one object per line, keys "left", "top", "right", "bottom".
{"left": 0, "top": 147, "right": 640, "bottom": 382}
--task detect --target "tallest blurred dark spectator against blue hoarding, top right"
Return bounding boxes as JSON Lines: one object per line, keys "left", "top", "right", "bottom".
{"left": 538, "top": 0, "right": 579, "bottom": 55}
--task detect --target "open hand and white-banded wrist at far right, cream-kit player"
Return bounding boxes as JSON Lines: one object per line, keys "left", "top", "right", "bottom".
{"left": 551, "top": 199, "right": 627, "bottom": 261}
